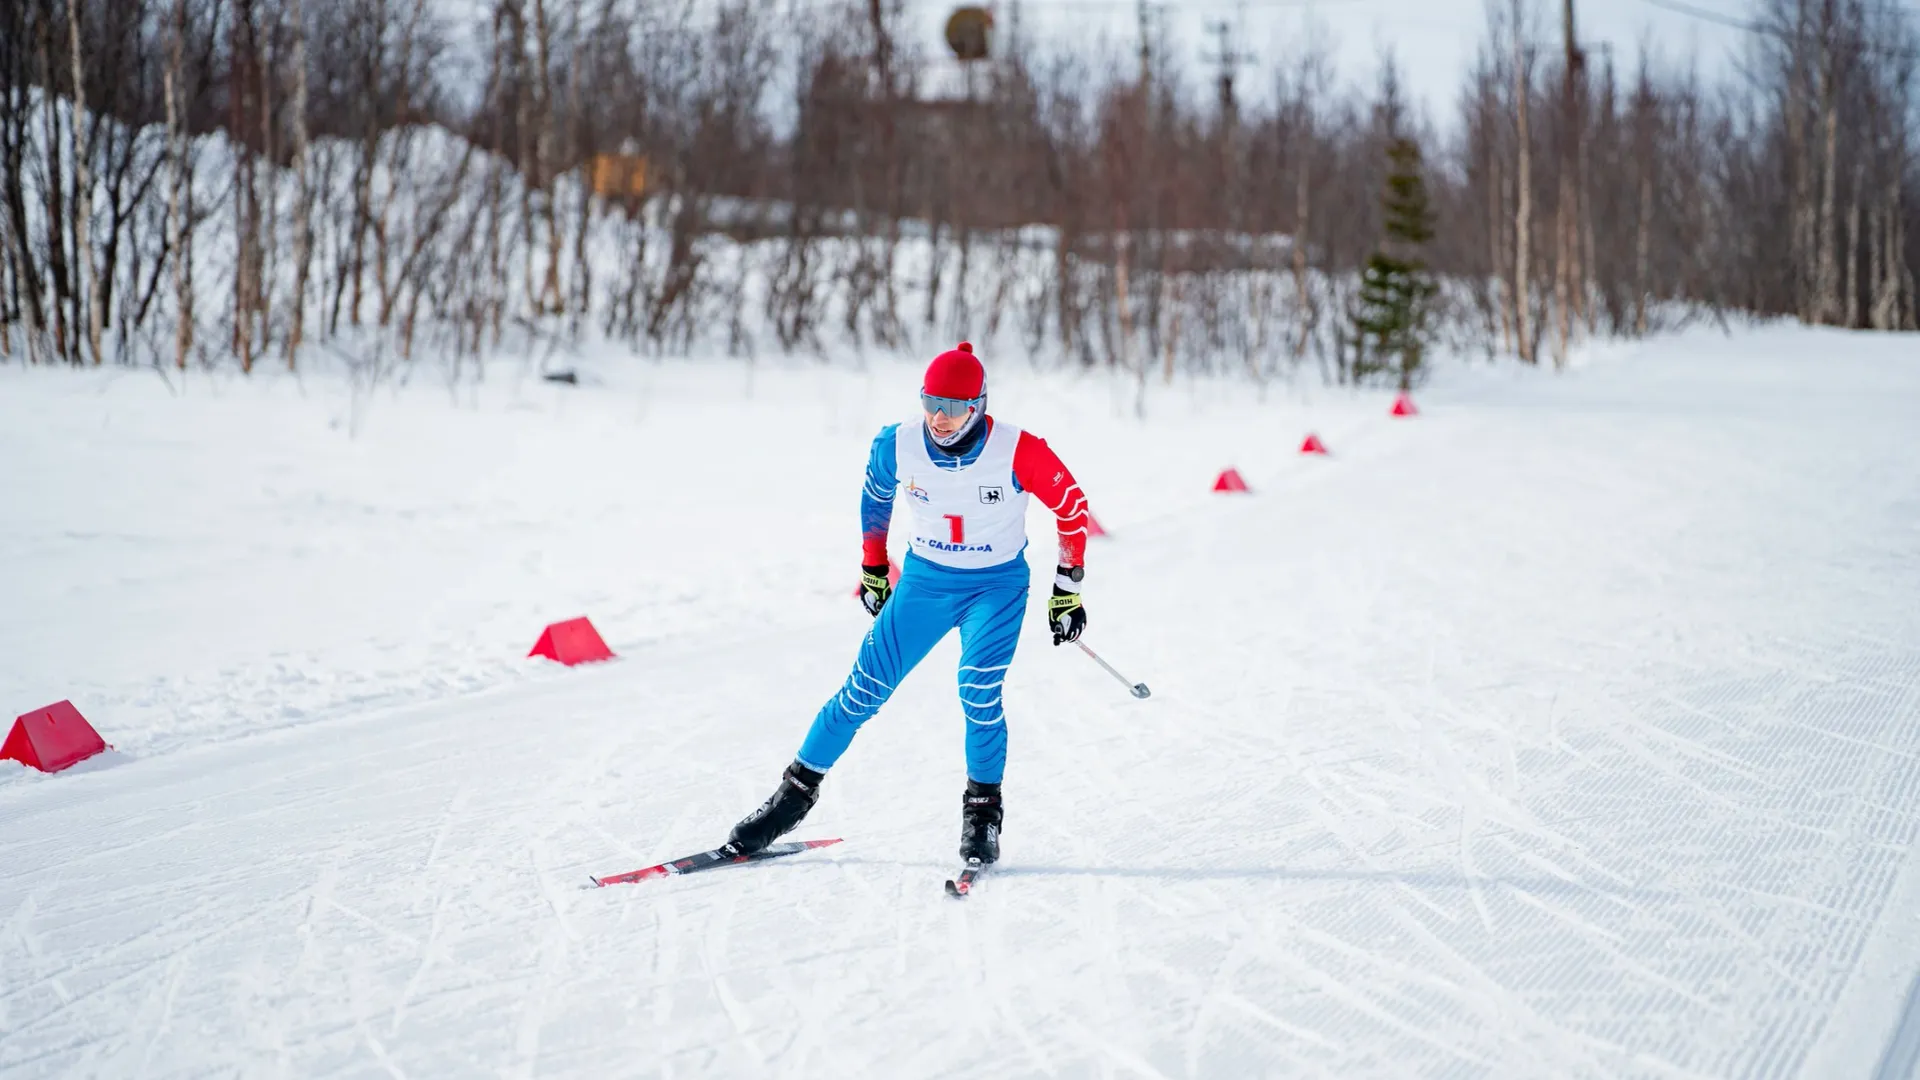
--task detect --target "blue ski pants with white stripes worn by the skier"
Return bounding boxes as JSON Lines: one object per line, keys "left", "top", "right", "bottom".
{"left": 797, "top": 555, "right": 1031, "bottom": 784}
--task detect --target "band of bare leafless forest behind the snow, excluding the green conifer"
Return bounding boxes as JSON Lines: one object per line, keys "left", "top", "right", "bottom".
{"left": 0, "top": 0, "right": 1920, "bottom": 382}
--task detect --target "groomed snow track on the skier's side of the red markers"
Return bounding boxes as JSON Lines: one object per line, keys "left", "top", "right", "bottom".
{"left": 0, "top": 332, "right": 1920, "bottom": 1080}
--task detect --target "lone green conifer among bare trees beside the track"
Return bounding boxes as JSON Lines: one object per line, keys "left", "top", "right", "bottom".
{"left": 1354, "top": 138, "right": 1438, "bottom": 390}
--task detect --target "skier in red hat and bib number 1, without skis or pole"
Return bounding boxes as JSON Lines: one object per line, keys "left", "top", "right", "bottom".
{"left": 724, "top": 342, "right": 1087, "bottom": 865}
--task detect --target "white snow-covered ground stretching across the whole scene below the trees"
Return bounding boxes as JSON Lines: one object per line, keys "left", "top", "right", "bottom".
{"left": 0, "top": 329, "right": 1920, "bottom": 1080}
